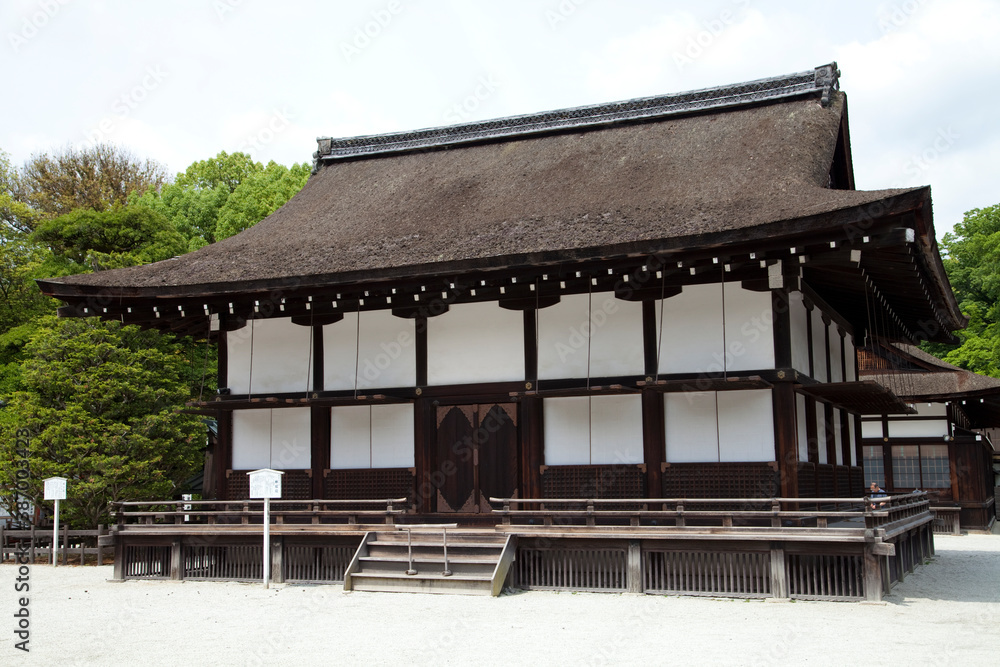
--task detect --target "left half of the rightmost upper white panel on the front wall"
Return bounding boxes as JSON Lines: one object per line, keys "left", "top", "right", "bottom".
{"left": 656, "top": 283, "right": 724, "bottom": 373}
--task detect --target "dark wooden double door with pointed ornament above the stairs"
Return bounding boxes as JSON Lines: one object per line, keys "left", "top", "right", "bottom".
{"left": 431, "top": 402, "right": 518, "bottom": 513}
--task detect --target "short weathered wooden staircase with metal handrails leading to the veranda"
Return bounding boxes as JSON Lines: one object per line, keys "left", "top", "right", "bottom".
{"left": 344, "top": 525, "right": 516, "bottom": 596}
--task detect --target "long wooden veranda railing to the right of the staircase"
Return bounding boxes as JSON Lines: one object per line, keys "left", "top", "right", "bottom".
{"left": 490, "top": 492, "right": 930, "bottom": 530}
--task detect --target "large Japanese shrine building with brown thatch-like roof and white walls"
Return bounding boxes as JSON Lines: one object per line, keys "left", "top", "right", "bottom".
{"left": 41, "top": 64, "right": 965, "bottom": 520}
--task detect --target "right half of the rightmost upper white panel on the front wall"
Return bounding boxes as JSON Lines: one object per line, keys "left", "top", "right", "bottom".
{"left": 725, "top": 282, "right": 774, "bottom": 374}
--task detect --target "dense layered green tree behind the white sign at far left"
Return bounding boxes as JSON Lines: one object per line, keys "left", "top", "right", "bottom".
{"left": 0, "top": 317, "right": 205, "bottom": 527}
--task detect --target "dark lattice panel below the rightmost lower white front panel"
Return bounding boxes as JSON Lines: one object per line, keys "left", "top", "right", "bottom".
{"left": 663, "top": 463, "right": 780, "bottom": 498}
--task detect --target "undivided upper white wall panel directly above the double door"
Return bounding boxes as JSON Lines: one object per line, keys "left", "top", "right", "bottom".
{"left": 427, "top": 302, "right": 524, "bottom": 385}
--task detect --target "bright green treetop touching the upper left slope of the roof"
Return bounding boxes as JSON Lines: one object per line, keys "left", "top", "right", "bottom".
{"left": 215, "top": 162, "right": 312, "bottom": 240}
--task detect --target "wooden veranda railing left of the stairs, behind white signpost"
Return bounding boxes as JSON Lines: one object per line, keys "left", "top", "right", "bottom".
{"left": 111, "top": 498, "right": 409, "bottom": 527}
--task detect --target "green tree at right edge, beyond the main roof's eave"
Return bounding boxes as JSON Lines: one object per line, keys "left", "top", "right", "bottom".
{"left": 924, "top": 204, "right": 1000, "bottom": 377}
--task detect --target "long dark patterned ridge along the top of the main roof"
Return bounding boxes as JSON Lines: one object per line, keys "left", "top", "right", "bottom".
{"left": 313, "top": 62, "right": 840, "bottom": 168}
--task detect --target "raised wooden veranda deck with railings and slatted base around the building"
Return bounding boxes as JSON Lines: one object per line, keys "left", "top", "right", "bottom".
{"left": 108, "top": 493, "right": 934, "bottom": 601}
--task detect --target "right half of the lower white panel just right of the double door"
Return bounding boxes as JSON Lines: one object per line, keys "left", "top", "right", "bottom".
{"left": 590, "top": 394, "right": 644, "bottom": 464}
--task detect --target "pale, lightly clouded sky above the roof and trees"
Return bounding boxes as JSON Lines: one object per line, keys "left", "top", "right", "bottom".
{"left": 0, "top": 0, "right": 1000, "bottom": 237}
